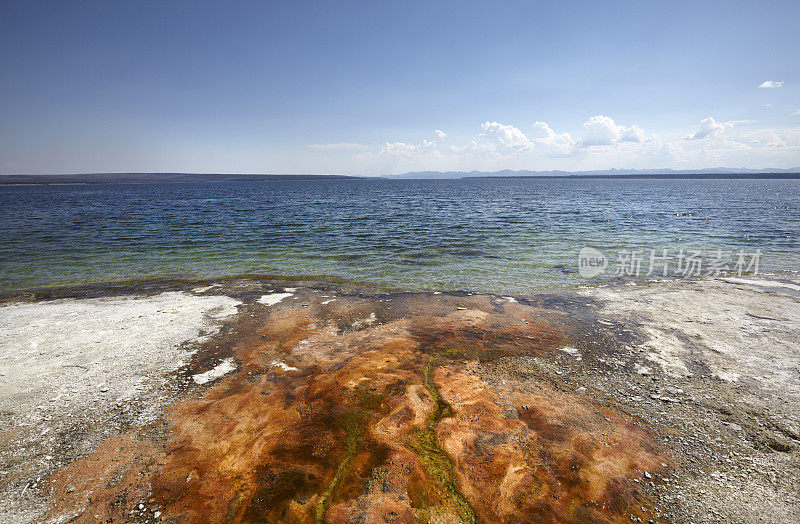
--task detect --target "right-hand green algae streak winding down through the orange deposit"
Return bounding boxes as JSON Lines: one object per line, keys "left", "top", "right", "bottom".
{"left": 408, "top": 357, "right": 477, "bottom": 524}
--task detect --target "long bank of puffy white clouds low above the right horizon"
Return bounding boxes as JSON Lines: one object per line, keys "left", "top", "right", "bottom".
{"left": 326, "top": 111, "right": 800, "bottom": 174}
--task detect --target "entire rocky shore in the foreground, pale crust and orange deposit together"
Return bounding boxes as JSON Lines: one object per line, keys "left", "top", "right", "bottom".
{"left": 0, "top": 277, "right": 800, "bottom": 522}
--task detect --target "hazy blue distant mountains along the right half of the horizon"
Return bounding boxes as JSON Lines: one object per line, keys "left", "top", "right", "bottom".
{"left": 382, "top": 167, "right": 800, "bottom": 179}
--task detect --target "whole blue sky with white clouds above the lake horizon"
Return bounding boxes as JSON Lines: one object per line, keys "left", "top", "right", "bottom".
{"left": 0, "top": 0, "right": 800, "bottom": 174}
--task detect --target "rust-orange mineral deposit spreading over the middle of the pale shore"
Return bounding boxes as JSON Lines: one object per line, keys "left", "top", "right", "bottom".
{"left": 49, "top": 293, "right": 664, "bottom": 523}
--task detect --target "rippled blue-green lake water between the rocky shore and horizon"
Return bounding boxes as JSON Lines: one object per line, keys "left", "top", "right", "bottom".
{"left": 0, "top": 179, "right": 800, "bottom": 293}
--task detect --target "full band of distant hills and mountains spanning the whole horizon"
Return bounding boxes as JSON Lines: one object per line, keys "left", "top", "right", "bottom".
{"left": 0, "top": 167, "right": 800, "bottom": 185}
